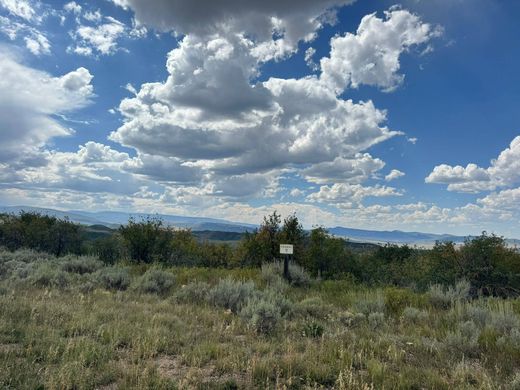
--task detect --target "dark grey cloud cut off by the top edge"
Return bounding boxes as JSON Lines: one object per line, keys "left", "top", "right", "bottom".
{"left": 108, "top": 0, "right": 352, "bottom": 53}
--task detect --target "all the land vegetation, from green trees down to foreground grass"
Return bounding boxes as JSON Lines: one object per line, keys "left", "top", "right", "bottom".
{"left": 0, "top": 214, "right": 520, "bottom": 389}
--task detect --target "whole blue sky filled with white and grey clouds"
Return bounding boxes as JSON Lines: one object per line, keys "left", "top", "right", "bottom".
{"left": 0, "top": 0, "right": 520, "bottom": 238}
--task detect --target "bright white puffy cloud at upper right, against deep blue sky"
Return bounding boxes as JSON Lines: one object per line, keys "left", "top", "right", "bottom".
{"left": 321, "top": 8, "right": 440, "bottom": 92}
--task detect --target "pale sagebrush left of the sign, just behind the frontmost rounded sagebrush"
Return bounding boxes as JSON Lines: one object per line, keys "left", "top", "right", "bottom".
{"left": 208, "top": 278, "right": 258, "bottom": 313}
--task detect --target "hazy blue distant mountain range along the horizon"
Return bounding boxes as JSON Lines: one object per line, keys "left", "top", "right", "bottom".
{"left": 0, "top": 206, "right": 520, "bottom": 246}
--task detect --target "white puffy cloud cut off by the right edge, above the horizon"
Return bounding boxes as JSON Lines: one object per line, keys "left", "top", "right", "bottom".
{"left": 425, "top": 136, "right": 520, "bottom": 192}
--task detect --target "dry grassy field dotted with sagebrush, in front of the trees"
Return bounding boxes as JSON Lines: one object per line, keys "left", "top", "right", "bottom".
{"left": 0, "top": 251, "right": 520, "bottom": 389}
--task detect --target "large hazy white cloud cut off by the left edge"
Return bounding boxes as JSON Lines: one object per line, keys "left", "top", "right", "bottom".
{"left": 0, "top": 51, "right": 93, "bottom": 165}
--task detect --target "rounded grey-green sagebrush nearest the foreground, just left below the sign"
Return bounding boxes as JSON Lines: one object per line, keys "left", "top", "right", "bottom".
{"left": 240, "top": 298, "right": 282, "bottom": 334}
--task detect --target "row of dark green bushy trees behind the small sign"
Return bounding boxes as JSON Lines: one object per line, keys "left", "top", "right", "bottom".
{"left": 0, "top": 212, "right": 520, "bottom": 297}
